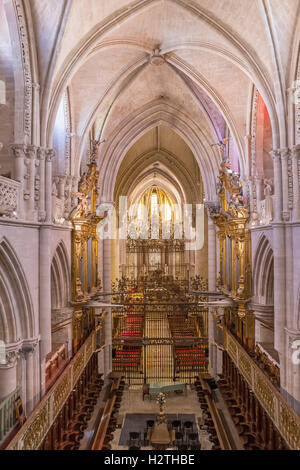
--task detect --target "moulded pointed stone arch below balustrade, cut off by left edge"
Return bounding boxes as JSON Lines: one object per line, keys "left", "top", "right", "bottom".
{"left": 0, "top": 238, "right": 35, "bottom": 344}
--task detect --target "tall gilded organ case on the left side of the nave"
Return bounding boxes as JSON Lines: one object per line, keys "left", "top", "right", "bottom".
{"left": 71, "top": 151, "right": 103, "bottom": 353}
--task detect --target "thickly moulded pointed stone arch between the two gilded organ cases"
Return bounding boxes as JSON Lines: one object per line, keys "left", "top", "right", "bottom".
{"left": 99, "top": 99, "right": 220, "bottom": 201}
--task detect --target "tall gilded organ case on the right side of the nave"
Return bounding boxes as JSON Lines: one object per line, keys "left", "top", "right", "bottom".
{"left": 211, "top": 162, "right": 254, "bottom": 350}
